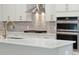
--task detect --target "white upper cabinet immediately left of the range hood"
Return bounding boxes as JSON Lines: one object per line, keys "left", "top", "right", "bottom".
{"left": 15, "top": 4, "right": 32, "bottom": 21}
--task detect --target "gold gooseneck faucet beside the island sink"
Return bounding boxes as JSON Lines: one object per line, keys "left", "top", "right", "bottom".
{"left": 3, "top": 21, "right": 15, "bottom": 39}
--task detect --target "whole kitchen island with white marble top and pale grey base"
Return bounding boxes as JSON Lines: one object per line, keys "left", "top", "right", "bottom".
{"left": 0, "top": 37, "right": 75, "bottom": 55}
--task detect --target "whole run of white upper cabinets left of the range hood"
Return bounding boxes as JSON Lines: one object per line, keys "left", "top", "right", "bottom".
{"left": 0, "top": 4, "right": 32, "bottom": 21}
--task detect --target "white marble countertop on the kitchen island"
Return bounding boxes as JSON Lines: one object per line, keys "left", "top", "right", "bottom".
{"left": 0, "top": 33, "right": 75, "bottom": 48}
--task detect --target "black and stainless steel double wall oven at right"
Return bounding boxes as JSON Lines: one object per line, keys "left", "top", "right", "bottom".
{"left": 57, "top": 17, "right": 78, "bottom": 49}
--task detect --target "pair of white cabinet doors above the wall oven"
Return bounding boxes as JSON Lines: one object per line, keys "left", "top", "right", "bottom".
{"left": 56, "top": 4, "right": 79, "bottom": 12}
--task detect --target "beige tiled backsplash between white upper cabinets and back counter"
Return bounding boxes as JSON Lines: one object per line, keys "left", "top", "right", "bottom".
{"left": 0, "top": 21, "right": 56, "bottom": 33}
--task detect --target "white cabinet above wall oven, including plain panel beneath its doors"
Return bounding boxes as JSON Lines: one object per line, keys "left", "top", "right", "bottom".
{"left": 56, "top": 4, "right": 79, "bottom": 17}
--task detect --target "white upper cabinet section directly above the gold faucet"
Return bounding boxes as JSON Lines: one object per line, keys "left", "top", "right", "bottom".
{"left": 2, "top": 4, "right": 16, "bottom": 21}
